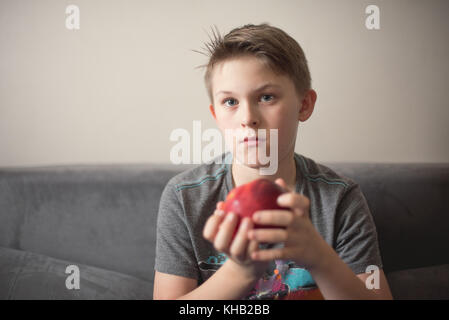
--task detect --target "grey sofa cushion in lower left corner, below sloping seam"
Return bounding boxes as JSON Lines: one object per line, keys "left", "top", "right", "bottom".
{"left": 0, "top": 247, "right": 153, "bottom": 300}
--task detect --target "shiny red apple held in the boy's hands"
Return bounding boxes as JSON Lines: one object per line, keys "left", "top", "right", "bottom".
{"left": 223, "top": 179, "right": 289, "bottom": 236}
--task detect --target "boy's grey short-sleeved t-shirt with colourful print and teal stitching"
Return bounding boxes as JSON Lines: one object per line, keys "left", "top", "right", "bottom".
{"left": 155, "top": 152, "right": 382, "bottom": 299}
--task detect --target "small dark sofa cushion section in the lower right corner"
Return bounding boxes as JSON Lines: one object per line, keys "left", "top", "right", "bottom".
{"left": 386, "top": 264, "right": 449, "bottom": 300}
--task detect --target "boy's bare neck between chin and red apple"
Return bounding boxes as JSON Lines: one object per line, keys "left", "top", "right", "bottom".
{"left": 232, "top": 152, "right": 296, "bottom": 190}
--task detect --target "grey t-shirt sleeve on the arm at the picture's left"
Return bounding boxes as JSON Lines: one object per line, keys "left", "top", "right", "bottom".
{"left": 154, "top": 183, "right": 198, "bottom": 279}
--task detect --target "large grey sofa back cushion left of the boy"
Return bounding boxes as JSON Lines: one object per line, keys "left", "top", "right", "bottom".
{"left": 0, "top": 165, "right": 191, "bottom": 281}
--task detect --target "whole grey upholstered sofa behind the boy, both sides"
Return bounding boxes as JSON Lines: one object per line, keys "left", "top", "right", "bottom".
{"left": 0, "top": 163, "right": 449, "bottom": 299}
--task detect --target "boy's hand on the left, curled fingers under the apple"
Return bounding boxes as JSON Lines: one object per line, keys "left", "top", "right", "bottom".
{"left": 203, "top": 201, "right": 268, "bottom": 278}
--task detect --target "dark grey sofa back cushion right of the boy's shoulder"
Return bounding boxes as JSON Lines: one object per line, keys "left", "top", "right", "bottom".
{"left": 330, "top": 163, "right": 449, "bottom": 273}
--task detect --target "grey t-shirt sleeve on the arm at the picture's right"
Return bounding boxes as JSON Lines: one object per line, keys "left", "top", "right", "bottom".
{"left": 335, "top": 183, "right": 382, "bottom": 274}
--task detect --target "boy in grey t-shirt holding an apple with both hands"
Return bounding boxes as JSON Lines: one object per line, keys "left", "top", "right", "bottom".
{"left": 154, "top": 24, "right": 391, "bottom": 299}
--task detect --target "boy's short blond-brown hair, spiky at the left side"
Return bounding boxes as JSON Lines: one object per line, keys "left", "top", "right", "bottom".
{"left": 193, "top": 23, "right": 311, "bottom": 103}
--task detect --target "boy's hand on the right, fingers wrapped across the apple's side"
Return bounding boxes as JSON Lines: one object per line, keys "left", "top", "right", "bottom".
{"left": 248, "top": 179, "right": 327, "bottom": 269}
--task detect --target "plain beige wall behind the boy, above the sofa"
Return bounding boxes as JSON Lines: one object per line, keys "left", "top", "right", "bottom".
{"left": 0, "top": 0, "right": 449, "bottom": 166}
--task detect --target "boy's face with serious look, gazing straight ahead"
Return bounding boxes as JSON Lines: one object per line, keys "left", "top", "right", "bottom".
{"left": 210, "top": 57, "right": 313, "bottom": 168}
